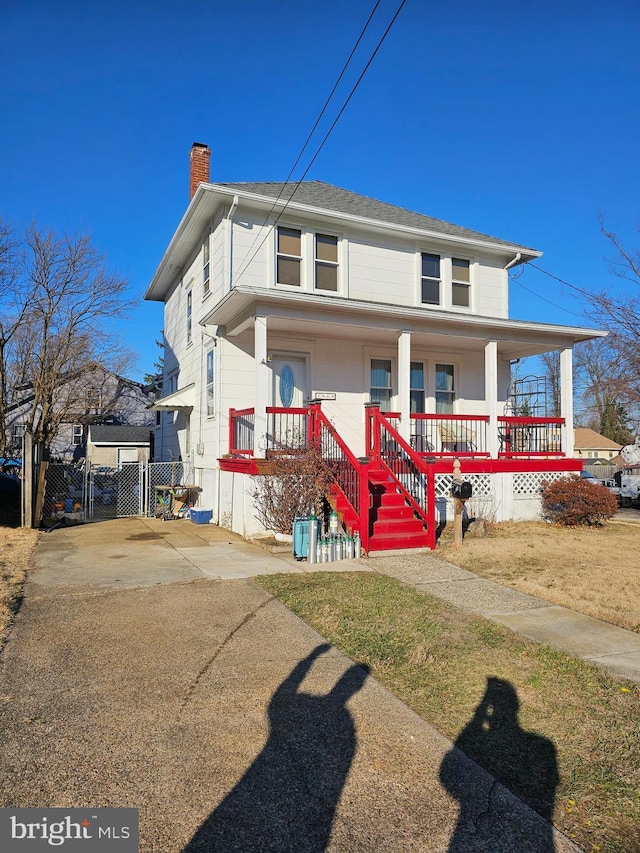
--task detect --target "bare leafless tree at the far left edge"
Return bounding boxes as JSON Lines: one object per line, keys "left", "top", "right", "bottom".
{"left": 0, "top": 225, "right": 129, "bottom": 456}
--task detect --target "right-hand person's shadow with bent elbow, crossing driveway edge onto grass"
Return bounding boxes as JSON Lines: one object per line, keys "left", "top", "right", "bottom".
{"left": 440, "top": 678, "right": 559, "bottom": 853}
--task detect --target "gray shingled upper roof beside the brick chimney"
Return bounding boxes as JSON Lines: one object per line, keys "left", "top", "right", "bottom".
{"left": 218, "top": 176, "right": 535, "bottom": 251}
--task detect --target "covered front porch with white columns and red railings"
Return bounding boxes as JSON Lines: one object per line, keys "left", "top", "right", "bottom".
{"left": 204, "top": 287, "right": 598, "bottom": 460}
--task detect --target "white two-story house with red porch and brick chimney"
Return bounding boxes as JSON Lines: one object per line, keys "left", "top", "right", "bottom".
{"left": 145, "top": 144, "right": 604, "bottom": 550}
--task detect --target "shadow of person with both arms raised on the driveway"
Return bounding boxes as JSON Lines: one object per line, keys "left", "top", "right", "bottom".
{"left": 182, "top": 644, "right": 368, "bottom": 853}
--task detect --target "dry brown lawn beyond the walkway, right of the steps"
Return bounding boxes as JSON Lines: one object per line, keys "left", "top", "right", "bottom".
{"left": 436, "top": 521, "right": 640, "bottom": 633}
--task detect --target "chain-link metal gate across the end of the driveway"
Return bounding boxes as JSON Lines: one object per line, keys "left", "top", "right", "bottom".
{"left": 42, "top": 462, "right": 193, "bottom": 520}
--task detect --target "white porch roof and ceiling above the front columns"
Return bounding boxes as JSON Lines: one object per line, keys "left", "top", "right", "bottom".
{"left": 202, "top": 286, "right": 606, "bottom": 359}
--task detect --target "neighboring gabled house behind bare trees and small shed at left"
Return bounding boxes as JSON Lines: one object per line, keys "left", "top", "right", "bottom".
{"left": 9, "top": 367, "right": 157, "bottom": 462}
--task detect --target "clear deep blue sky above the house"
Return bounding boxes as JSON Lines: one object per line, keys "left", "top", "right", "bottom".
{"left": 0, "top": 0, "right": 640, "bottom": 378}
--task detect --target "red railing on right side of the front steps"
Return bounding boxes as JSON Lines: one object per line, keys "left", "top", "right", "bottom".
{"left": 367, "top": 406, "right": 436, "bottom": 549}
